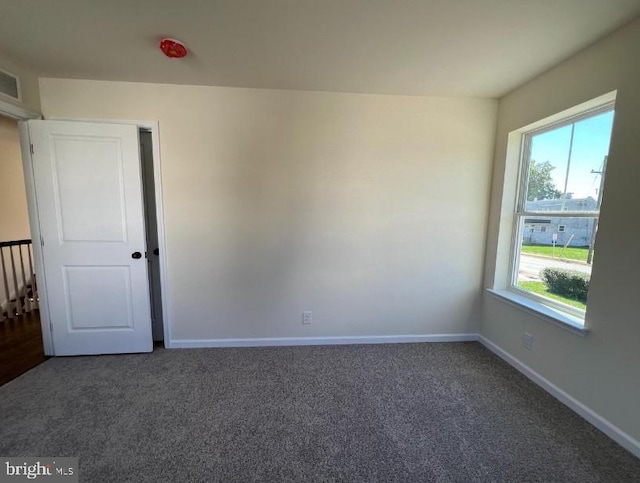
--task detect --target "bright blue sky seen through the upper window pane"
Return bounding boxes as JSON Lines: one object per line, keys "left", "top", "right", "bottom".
{"left": 531, "top": 111, "right": 613, "bottom": 199}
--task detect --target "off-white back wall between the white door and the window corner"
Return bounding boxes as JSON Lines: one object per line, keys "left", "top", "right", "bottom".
{"left": 40, "top": 79, "right": 497, "bottom": 339}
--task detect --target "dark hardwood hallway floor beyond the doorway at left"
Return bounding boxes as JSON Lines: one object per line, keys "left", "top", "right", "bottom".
{"left": 0, "top": 310, "right": 46, "bottom": 385}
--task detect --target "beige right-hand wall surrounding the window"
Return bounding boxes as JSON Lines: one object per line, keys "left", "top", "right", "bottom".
{"left": 481, "top": 19, "right": 640, "bottom": 439}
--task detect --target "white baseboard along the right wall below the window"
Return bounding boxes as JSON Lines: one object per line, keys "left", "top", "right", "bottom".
{"left": 477, "top": 335, "right": 640, "bottom": 458}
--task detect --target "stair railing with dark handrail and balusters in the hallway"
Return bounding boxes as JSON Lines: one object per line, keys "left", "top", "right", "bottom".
{"left": 0, "top": 240, "right": 38, "bottom": 320}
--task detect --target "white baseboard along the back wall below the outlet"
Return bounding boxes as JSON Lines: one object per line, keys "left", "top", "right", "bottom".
{"left": 166, "top": 334, "right": 478, "bottom": 349}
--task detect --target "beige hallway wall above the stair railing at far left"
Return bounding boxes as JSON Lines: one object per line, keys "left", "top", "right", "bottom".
{"left": 0, "top": 116, "right": 31, "bottom": 241}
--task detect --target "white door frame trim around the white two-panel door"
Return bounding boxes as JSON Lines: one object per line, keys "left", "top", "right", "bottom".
{"left": 0, "top": 104, "right": 171, "bottom": 356}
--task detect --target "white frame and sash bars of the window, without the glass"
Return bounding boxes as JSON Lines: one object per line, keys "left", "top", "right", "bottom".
{"left": 507, "top": 100, "right": 615, "bottom": 324}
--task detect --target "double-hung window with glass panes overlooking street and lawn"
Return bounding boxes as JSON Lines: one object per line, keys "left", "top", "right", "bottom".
{"left": 510, "top": 103, "right": 614, "bottom": 319}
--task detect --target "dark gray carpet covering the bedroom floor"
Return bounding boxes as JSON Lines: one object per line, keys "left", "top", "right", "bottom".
{"left": 0, "top": 343, "right": 640, "bottom": 483}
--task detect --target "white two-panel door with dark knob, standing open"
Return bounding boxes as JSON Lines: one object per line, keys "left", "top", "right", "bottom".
{"left": 28, "top": 121, "right": 153, "bottom": 355}
